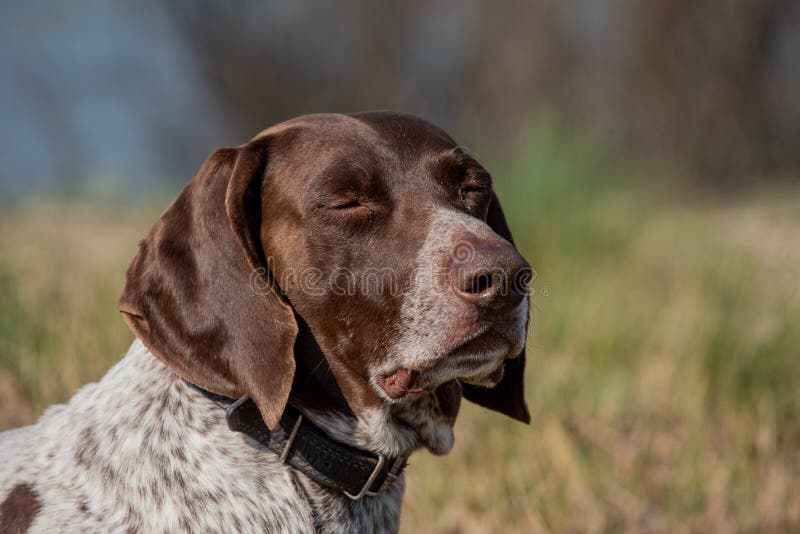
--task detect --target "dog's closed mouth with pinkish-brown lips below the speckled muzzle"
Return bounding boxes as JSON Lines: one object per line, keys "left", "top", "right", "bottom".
{"left": 376, "top": 331, "right": 510, "bottom": 399}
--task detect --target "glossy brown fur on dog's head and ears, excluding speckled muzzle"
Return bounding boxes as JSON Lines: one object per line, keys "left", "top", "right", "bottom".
{"left": 120, "top": 113, "right": 529, "bottom": 434}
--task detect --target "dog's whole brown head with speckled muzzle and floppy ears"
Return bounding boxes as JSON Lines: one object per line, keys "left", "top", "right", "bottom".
{"left": 120, "top": 112, "right": 531, "bottom": 454}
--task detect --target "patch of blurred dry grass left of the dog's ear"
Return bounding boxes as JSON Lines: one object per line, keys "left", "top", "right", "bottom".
{"left": 0, "top": 201, "right": 157, "bottom": 414}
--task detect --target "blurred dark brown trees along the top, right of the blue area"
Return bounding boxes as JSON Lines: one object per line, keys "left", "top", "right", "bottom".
{"left": 158, "top": 0, "right": 800, "bottom": 182}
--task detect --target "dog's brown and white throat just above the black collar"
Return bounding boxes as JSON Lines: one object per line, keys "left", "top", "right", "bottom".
{"left": 290, "top": 331, "right": 461, "bottom": 456}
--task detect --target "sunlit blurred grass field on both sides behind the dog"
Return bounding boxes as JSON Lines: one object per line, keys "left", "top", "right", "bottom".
{"left": 0, "top": 130, "right": 800, "bottom": 533}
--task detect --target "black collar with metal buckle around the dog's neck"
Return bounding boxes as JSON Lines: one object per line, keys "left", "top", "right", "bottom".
{"left": 186, "top": 382, "right": 408, "bottom": 500}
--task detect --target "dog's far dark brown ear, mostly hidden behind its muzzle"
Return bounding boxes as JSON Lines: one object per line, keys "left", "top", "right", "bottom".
{"left": 462, "top": 194, "right": 531, "bottom": 423}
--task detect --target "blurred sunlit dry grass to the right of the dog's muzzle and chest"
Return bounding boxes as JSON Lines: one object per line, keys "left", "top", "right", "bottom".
{"left": 404, "top": 194, "right": 800, "bottom": 533}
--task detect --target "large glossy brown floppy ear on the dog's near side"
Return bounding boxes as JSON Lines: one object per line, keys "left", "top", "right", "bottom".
{"left": 119, "top": 137, "right": 297, "bottom": 428}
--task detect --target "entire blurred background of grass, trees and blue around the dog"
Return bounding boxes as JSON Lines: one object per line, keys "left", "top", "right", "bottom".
{"left": 0, "top": 0, "right": 800, "bottom": 533}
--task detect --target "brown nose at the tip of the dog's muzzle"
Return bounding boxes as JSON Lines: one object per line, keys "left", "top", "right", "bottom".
{"left": 450, "top": 238, "right": 532, "bottom": 310}
